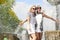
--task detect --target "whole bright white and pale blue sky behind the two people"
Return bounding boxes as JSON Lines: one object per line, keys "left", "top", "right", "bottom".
{"left": 13, "top": 0, "right": 56, "bottom": 30}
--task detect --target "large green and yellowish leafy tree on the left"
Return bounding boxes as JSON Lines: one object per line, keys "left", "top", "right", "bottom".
{"left": 0, "top": 0, "right": 20, "bottom": 33}
